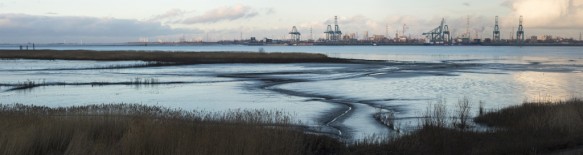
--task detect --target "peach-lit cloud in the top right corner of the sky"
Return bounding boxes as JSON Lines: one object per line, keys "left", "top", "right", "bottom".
{"left": 503, "top": 0, "right": 583, "bottom": 29}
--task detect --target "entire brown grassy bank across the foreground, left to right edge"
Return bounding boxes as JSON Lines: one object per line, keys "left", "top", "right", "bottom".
{"left": 0, "top": 99, "right": 583, "bottom": 154}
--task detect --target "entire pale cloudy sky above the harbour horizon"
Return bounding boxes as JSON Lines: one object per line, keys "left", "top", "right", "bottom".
{"left": 0, "top": 0, "right": 583, "bottom": 43}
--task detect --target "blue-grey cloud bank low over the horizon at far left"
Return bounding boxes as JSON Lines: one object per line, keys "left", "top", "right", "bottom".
{"left": 0, "top": 14, "right": 198, "bottom": 43}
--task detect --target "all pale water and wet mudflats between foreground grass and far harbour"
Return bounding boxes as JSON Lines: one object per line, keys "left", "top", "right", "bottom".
{"left": 0, "top": 45, "right": 583, "bottom": 140}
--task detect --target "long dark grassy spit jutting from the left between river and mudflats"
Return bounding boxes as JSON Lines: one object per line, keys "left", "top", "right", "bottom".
{"left": 0, "top": 50, "right": 346, "bottom": 64}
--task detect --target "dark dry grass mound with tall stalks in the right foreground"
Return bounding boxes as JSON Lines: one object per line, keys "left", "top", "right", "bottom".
{"left": 349, "top": 99, "right": 583, "bottom": 154}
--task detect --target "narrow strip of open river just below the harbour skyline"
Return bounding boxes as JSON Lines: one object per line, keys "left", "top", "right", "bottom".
{"left": 0, "top": 45, "right": 583, "bottom": 61}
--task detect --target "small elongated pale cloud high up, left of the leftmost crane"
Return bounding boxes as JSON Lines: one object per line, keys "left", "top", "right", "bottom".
{"left": 180, "top": 5, "right": 259, "bottom": 24}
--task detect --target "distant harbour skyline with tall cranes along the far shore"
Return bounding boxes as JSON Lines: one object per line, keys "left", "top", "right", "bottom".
{"left": 264, "top": 16, "right": 583, "bottom": 46}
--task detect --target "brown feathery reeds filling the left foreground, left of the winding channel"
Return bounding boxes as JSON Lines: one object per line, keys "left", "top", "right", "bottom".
{"left": 0, "top": 104, "right": 343, "bottom": 154}
